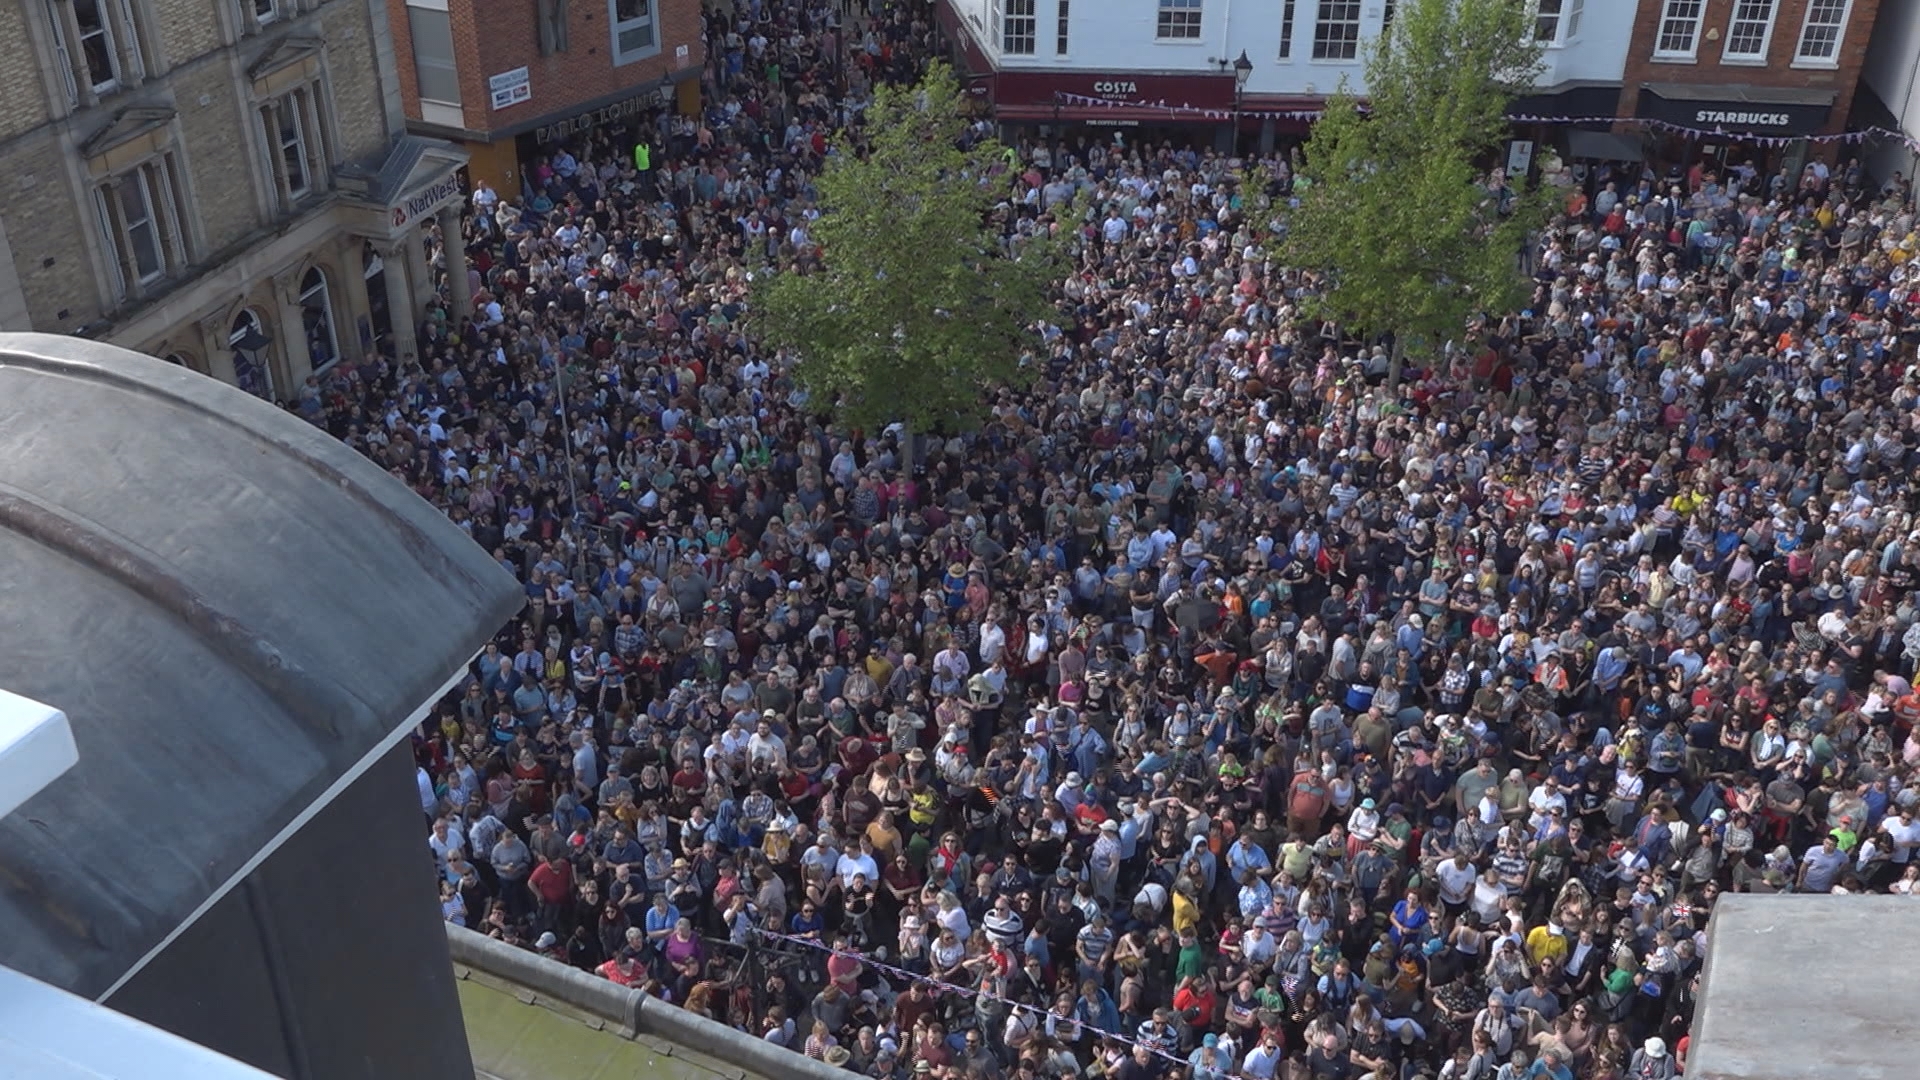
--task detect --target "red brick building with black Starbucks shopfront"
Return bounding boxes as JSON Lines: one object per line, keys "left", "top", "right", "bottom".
{"left": 1620, "top": 0, "right": 1882, "bottom": 154}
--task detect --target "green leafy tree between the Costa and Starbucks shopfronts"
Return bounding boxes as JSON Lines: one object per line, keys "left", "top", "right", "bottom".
{"left": 1279, "top": 0, "right": 1548, "bottom": 386}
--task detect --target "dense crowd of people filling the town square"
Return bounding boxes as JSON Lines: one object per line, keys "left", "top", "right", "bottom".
{"left": 305, "top": 0, "right": 1920, "bottom": 1080}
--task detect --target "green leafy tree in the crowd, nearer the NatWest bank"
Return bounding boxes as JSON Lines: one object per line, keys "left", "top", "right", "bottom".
{"left": 751, "top": 63, "right": 1064, "bottom": 442}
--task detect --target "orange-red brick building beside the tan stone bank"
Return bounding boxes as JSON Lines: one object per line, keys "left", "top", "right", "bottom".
{"left": 388, "top": 0, "right": 707, "bottom": 194}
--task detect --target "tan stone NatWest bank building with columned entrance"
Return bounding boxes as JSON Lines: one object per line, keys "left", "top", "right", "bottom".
{"left": 0, "top": 0, "right": 465, "bottom": 400}
